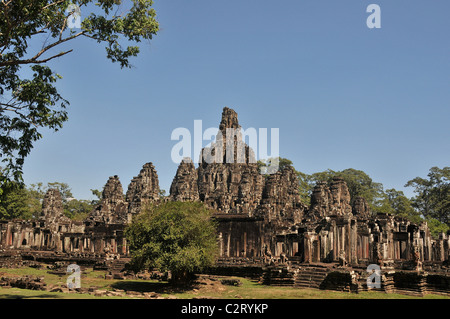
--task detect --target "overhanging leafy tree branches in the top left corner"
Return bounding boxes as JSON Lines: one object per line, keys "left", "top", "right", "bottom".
{"left": 0, "top": 0, "right": 159, "bottom": 186}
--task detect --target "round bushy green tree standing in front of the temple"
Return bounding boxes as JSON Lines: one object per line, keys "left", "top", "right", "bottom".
{"left": 126, "top": 202, "right": 218, "bottom": 284}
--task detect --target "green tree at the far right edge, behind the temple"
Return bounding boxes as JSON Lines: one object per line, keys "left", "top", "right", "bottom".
{"left": 405, "top": 166, "right": 450, "bottom": 226}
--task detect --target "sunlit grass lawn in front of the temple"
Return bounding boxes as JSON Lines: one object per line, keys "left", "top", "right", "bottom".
{"left": 0, "top": 267, "right": 449, "bottom": 299}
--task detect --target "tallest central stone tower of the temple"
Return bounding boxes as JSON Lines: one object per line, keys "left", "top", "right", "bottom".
{"left": 198, "top": 108, "right": 264, "bottom": 216}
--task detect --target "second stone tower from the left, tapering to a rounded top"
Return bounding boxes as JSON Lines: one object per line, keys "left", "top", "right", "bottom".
{"left": 89, "top": 175, "right": 128, "bottom": 224}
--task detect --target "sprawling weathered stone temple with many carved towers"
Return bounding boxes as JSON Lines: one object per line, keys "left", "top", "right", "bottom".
{"left": 0, "top": 108, "right": 450, "bottom": 294}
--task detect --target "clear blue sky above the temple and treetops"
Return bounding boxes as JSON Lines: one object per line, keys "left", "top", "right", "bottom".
{"left": 24, "top": 0, "right": 450, "bottom": 199}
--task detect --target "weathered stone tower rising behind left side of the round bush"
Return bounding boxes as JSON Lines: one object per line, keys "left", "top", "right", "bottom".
{"left": 126, "top": 163, "right": 159, "bottom": 215}
